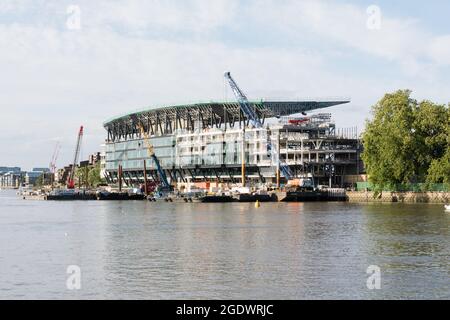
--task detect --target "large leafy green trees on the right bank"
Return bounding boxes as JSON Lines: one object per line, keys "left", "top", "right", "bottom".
{"left": 362, "top": 90, "right": 450, "bottom": 188}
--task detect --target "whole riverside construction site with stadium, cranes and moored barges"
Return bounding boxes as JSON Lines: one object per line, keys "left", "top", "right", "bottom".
{"left": 14, "top": 72, "right": 364, "bottom": 202}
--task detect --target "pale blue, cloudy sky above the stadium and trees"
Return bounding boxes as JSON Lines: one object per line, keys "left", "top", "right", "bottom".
{"left": 0, "top": 0, "right": 450, "bottom": 170}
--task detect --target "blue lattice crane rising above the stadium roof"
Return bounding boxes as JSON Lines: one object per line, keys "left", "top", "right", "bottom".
{"left": 224, "top": 72, "right": 293, "bottom": 180}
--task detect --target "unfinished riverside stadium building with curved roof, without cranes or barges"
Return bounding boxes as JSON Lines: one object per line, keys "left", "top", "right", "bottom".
{"left": 104, "top": 82, "right": 363, "bottom": 190}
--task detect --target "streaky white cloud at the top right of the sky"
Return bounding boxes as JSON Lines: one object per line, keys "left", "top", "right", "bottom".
{"left": 249, "top": 0, "right": 436, "bottom": 70}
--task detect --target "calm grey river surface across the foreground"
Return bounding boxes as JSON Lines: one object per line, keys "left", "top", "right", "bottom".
{"left": 0, "top": 191, "right": 450, "bottom": 299}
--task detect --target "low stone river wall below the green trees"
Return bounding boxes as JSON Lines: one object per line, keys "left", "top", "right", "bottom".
{"left": 347, "top": 191, "right": 450, "bottom": 204}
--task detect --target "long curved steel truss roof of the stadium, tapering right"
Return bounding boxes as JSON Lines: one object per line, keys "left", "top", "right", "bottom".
{"left": 104, "top": 99, "right": 350, "bottom": 142}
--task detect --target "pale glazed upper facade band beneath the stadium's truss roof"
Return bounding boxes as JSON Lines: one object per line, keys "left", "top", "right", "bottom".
{"left": 105, "top": 129, "right": 274, "bottom": 171}
